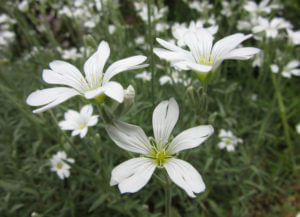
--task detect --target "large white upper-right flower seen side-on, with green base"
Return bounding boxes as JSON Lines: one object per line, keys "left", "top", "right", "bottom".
{"left": 154, "top": 28, "right": 260, "bottom": 77}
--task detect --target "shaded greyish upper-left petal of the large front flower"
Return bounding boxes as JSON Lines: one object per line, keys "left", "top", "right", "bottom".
{"left": 106, "top": 121, "right": 151, "bottom": 155}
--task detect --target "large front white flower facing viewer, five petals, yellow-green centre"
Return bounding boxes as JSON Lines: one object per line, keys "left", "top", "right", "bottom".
{"left": 106, "top": 98, "right": 213, "bottom": 197}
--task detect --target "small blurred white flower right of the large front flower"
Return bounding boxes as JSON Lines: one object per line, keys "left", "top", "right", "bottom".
{"left": 218, "top": 129, "right": 243, "bottom": 152}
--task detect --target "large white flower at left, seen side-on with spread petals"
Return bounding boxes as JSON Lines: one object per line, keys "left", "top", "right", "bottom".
{"left": 26, "top": 41, "right": 147, "bottom": 113}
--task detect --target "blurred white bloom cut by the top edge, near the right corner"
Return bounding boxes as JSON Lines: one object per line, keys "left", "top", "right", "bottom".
{"left": 244, "top": 0, "right": 280, "bottom": 15}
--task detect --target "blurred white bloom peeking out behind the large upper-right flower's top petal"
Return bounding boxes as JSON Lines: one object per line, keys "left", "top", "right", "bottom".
{"left": 172, "top": 20, "right": 219, "bottom": 47}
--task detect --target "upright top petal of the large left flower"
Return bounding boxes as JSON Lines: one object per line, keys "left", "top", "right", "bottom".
{"left": 84, "top": 41, "right": 110, "bottom": 84}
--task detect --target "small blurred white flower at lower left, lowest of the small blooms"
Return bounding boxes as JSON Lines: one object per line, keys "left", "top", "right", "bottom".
{"left": 50, "top": 151, "right": 75, "bottom": 179}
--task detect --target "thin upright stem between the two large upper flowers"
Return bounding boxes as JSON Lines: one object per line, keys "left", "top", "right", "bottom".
{"left": 147, "top": 0, "right": 155, "bottom": 107}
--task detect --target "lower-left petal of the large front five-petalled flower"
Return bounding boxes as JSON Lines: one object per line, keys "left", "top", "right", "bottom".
{"left": 110, "top": 157, "right": 156, "bottom": 194}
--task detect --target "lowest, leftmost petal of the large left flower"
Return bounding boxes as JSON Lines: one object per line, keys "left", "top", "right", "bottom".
{"left": 26, "top": 87, "right": 79, "bottom": 113}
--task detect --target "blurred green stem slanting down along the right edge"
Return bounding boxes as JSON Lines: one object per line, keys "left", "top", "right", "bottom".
{"left": 271, "top": 73, "right": 296, "bottom": 172}
